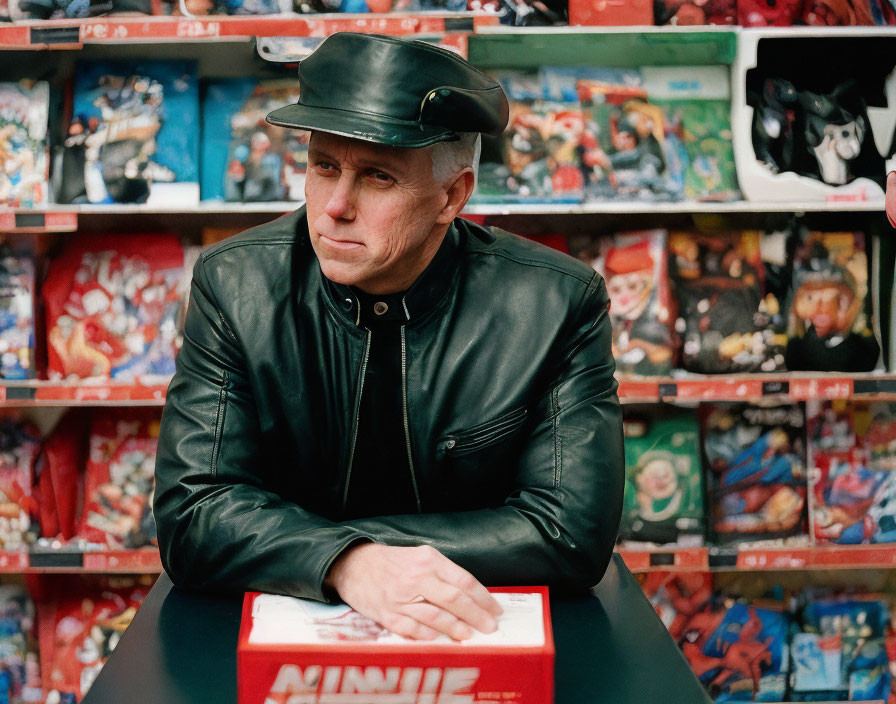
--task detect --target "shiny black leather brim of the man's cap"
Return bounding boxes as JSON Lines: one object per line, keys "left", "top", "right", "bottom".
{"left": 266, "top": 104, "right": 459, "bottom": 148}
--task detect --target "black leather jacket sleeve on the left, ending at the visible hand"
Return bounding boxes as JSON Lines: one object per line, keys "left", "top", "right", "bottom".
{"left": 153, "top": 258, "right": 366, "bottom": 600}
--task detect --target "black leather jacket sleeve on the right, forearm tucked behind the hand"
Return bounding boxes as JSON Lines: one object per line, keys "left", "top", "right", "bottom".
{"left": 343, "top": 275, "right": 624, "bottom": 589}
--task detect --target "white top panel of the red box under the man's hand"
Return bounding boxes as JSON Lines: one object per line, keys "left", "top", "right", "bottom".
{"left": 249, "top": 592, "right": 545, "bottom": 648}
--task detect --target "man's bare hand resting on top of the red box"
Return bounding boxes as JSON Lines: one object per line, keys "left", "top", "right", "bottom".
{"left": 325, "top": 543, "right": 502, "bottom": 640}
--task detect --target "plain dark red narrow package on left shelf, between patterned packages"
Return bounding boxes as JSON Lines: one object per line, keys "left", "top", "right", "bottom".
{"left": 35, "top": 411, "right": 89, "bottom": 540}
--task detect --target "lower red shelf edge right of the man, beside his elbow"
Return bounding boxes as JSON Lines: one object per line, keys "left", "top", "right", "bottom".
{"left": 618, "top": 544, "right": 896, "bottom": 572}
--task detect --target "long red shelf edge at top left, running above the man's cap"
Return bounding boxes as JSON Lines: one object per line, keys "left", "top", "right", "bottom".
{"left": 0, "top": 12, "right": 498, "bottom": 49}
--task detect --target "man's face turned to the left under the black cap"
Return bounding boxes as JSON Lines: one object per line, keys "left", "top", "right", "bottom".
{"left": 305, "top": 132, "right": 451, "bottom": 293}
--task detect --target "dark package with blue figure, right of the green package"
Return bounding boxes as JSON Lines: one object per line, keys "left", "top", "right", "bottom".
{"left": 700, "top": 404, "right": 807, "bottom": 544}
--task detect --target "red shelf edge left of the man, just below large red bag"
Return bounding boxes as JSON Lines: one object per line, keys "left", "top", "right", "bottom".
{"left": 0, "top": 381, "right": 168, "bottom": 407}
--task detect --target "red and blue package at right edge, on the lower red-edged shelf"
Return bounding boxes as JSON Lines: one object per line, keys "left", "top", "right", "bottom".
{"left": 809, "top": 401, "right": 896, "bottom": 545}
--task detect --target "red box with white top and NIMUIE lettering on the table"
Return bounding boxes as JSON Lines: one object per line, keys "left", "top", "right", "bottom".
{"left": 237, "top": 587, "right": 554, "bottom": 704}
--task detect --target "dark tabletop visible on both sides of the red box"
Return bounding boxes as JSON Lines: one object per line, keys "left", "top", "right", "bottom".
{"left": 82, "top": 555, "right": 710, "bottom": 704}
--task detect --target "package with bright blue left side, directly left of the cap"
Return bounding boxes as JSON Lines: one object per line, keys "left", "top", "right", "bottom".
{"left": 201, "top": 78, "right": 309, "bottom": 202}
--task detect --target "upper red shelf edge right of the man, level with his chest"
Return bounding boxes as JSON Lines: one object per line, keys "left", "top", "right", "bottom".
{"left": 619, "top": 372, "right": 896, "bottom": 403}
